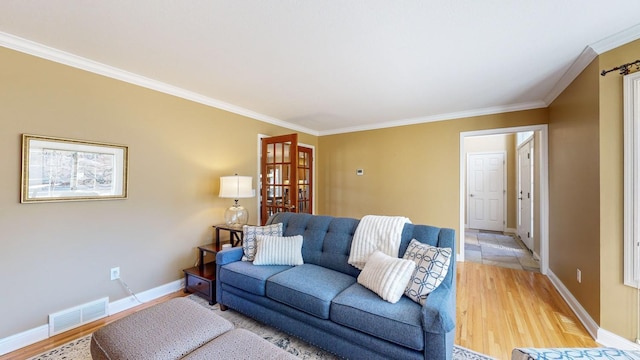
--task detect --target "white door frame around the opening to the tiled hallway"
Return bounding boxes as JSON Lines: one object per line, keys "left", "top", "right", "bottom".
{"left": 457, "top": 124, "right": 549, "bottom": 275}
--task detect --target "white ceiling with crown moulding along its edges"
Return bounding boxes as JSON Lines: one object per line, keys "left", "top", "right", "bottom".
{"left": 0, "top": 0, "right": 640, "bottom": 135}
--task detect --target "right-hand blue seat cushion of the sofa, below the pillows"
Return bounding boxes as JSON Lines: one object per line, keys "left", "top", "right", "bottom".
{"left": 330, "top": 283, "right": 424, "bottom": 351}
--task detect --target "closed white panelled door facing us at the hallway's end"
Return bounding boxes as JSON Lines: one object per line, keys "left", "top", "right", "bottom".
{"left": 467, "top": 153, "right": 505, "bottom": 231}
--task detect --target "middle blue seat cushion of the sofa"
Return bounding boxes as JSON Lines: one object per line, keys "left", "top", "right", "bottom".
{"left": 266, "top": 264, "right": 356, "bottom": 319}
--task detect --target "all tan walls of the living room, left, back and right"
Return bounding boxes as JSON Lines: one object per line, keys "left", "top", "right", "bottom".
{"left": 0, "top": 31, "right": 640, "bottom": 346}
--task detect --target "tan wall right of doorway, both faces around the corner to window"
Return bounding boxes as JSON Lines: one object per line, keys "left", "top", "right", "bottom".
{"left": 549, "top": 41, "right": 640, "bottom": 340}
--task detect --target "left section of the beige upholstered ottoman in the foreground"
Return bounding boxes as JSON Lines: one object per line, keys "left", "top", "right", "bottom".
{"left": 91, "top": 298, "right": 233, "bottom": 360}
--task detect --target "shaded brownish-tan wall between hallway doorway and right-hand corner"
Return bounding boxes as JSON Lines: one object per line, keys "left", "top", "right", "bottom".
{"left": 549, "top": 61, "right": 600, "bottom": 322}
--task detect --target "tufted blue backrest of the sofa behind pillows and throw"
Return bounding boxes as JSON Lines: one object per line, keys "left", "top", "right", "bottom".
{"left": 267, "top": 212, "right": 456, "bottom": 283}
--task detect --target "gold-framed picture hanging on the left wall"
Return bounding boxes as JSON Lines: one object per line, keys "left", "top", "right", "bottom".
{"left": 20, "top": 134, "right": 128, "bottom": 203}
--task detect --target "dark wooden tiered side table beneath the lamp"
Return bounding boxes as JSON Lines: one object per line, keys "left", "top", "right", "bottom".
{"left": 182, "top": 244, "right": 218, "bottom": 305}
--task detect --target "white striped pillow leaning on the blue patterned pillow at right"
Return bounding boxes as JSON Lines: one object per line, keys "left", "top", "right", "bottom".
{"left": 358, "top": 250, "right": 416, "bottom": 304}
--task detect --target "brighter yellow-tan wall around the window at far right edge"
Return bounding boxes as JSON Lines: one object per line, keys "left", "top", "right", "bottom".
{"left": 597, "top": 40, "right": 640, "bottom": 340}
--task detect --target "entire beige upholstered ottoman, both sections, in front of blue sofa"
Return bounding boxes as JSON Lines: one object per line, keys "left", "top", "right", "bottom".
{"left": 91, "top": 298, "right": 297, "bottom": 360}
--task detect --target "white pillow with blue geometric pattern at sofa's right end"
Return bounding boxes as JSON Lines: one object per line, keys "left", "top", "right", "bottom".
{"left": 402, "top": 239, "right": 452, "bottom": 305}
